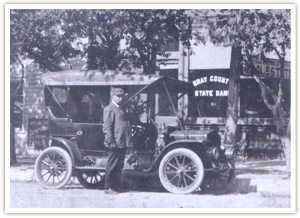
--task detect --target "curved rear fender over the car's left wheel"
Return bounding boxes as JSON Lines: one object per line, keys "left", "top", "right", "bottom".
{"left": 49, "top": 137, "right": 82, "bottom": 166}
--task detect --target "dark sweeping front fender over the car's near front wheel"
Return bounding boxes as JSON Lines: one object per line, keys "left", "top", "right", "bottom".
{"left": 145, "top": 139, "right": 209, "bottom": 172}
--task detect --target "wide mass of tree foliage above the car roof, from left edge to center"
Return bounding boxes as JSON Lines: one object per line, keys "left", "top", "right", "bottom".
{"left": 11, "top": 10, "right": 191, "bottom": 73}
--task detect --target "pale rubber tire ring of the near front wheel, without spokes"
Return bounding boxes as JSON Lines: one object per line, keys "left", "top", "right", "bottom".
{"left": 158, "top": 148, "right": 204, "bottom": 194}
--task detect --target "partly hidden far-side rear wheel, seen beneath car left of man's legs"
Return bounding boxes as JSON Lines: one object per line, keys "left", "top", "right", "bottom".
{"left": 76, "top": 170, "right": 105, "bottom": 189}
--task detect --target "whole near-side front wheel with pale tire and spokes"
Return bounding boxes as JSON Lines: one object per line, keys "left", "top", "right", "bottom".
{"left": 159, "top": 148, "right": 204, "bottom": 194}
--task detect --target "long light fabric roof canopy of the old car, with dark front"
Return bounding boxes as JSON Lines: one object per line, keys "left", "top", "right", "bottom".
{"left": 41, "top": 70, "right": 192, "bottom": 93}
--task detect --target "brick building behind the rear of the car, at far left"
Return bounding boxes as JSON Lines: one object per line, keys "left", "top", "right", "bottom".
{"left": 10, "top": 59, "right": 84, "bottom": 155}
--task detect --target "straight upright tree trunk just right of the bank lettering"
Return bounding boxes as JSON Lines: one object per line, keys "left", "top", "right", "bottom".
{"left": 225, "top": 46, "right": 242, "bottom": 145}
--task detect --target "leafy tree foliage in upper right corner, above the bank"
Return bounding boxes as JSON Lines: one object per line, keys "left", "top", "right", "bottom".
{"left": 207, "top": 9, "right": 291, "bottom": 55}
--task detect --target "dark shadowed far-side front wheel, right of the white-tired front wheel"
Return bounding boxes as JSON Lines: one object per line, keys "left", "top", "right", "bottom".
{"left": 201, "top": 160, "right": 235, "bottom": 194}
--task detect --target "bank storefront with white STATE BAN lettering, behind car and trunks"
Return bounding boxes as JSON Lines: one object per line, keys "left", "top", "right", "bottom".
{"left": 158, "top": 40, "right": 291, "bottom": 157}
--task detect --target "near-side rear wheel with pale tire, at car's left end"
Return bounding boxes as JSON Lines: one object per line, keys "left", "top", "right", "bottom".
{"left": 35, "top": 147, "right": 73, "bottom": 189}
